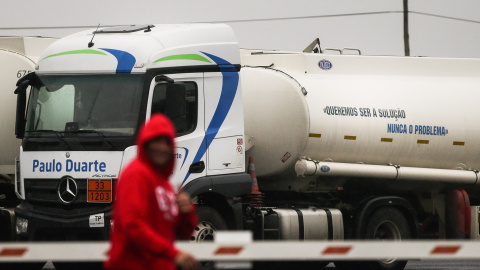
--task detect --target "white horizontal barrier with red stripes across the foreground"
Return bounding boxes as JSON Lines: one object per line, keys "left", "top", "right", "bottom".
{"left": 0, "top": 232, "right": 480, "bottom": 262}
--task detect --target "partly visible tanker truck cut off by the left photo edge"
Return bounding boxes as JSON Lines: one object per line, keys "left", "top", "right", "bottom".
{"left": 0, "top": 37, "right": 55, "bottom": 241}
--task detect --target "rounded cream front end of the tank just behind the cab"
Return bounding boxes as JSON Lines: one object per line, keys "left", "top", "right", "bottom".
{"left": 241, "top": 68, "right": 310, "bottom": 176}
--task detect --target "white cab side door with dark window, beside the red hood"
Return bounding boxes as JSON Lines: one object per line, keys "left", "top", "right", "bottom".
{"left": 147, "top": 73, "right": 206, "bottom": 188}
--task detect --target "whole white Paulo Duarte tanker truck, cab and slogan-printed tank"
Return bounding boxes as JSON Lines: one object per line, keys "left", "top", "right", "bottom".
{"left": 11, "top": 24, "right": 480, "bottom": 269}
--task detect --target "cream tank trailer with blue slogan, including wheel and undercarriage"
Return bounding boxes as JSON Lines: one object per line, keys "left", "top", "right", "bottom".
{"left": 240, "top": 51, "right": 480, "bottom": 269}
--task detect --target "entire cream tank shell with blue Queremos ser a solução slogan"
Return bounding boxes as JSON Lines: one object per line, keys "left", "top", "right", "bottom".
{"left": 241, "top": 50, "right": 480, "bottom": 181}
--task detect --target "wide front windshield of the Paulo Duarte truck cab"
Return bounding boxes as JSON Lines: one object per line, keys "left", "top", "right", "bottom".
{"left": 25, "top": 74, "right": 143, "bottom": 136}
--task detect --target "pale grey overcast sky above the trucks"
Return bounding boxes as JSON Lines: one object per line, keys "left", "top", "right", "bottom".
{"left": 0, "top": 0, "right": 480, "bottom": 58}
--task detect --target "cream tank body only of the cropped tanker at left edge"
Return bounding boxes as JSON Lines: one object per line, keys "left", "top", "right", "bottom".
{"left": 0, "top": 37, "right": 56, "bottom": 175}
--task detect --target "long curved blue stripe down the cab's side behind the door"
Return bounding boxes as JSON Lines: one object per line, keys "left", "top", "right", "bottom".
{"left": 182, "top": 52, "right": 239, "bottom": 185}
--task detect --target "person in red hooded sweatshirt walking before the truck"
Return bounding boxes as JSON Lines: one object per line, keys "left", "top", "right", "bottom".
{"left": 104, "top": 114, "right": 198, "bottom": 270}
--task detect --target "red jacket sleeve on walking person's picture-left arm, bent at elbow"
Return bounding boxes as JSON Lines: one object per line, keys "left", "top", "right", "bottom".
{"left": 114, "top": 171, "right": 179, "bottom": 260}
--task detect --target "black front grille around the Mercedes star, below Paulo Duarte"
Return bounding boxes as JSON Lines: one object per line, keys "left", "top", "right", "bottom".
{"left": 24, "top": 179, "right": 113, "bottom": 218}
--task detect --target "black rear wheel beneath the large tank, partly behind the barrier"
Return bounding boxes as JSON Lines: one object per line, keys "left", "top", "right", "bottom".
{"left": 364, "top": 207, "right": 411, "bottom": 270}
